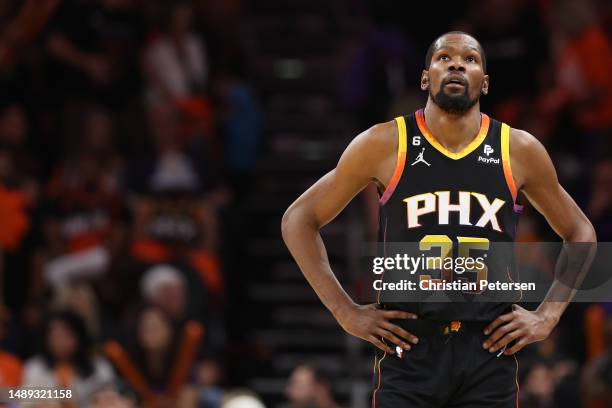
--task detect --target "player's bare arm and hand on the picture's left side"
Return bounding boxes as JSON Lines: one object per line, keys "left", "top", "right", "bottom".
{"left": 282, "top": 118, "right": 417, "bottom": 353}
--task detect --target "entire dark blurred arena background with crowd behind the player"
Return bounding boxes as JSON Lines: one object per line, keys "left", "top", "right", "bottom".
{"left": 0, "top": 0, "right": 612, "bottom": 408}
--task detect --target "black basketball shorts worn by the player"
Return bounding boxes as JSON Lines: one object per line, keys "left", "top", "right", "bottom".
{"left": 372, "top": 319, "right": 519, "bottom": 408}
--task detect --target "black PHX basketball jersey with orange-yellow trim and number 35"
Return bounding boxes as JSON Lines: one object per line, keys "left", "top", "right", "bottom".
{"left": 379, "top": 109, "right": 521, "bottom": 321}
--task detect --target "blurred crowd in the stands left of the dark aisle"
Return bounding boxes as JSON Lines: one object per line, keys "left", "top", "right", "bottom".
{"left": 0, "top": 0, "right": 261, "bottom": 407}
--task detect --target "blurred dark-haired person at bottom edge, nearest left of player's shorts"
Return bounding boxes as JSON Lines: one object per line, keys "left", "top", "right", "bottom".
{"left": 285, "top": 364, "right": 340, "bottom": 408}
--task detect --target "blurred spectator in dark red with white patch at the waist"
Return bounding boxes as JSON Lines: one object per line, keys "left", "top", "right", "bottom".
{"left": 45, "top": 108, "right": 127, "bottom": 287}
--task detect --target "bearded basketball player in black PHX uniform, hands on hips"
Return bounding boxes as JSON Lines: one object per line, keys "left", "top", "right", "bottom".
{"left": 282, "top": 32, "right": 596, "bottom": 408}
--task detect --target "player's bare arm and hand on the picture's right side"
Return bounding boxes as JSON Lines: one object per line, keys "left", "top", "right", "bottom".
{"left": 483, "top": 129, "right": 596, "bottom": 355}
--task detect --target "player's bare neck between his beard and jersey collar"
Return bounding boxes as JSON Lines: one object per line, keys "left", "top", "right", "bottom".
{"left": 424, "top": 97, "right": 481, "bottom": 152}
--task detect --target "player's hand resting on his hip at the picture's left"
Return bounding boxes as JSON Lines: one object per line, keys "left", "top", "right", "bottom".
{"left": 336, "top": 303, "right": 419, "bottom": 354}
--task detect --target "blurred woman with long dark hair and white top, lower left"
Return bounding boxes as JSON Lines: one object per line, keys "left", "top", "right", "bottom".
{"left": 23, "top": 312, "right": 115, "bottom": 405}
